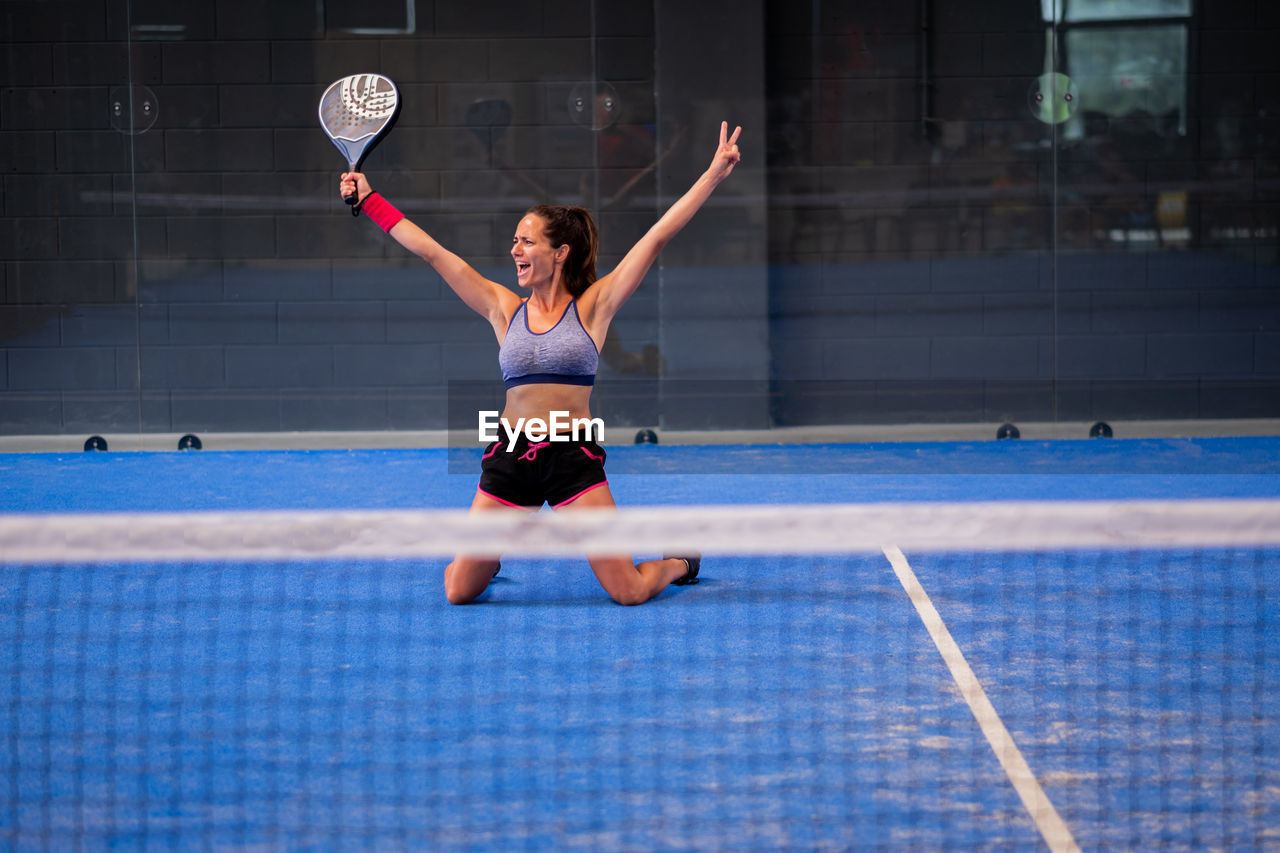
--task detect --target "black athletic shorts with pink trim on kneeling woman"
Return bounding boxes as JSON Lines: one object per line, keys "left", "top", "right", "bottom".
{"left": 480, "top": 433, "right": 608, "bottom": 507}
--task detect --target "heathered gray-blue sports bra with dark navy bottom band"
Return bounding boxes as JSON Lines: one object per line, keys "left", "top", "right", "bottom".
{"left": 498, "top": 300, "right": 600, "bottom": 388}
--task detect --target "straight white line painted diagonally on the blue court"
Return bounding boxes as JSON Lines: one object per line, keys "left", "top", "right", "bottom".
{"left": 884, "top": 546, "right": 1080, "bottom": 853}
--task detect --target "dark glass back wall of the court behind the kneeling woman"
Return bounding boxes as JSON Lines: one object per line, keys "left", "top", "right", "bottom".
{"left": 0, "top": 0, "right": 1280, "bottom": 446}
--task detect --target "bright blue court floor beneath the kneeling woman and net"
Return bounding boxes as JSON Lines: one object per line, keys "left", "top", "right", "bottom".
{"left": 0, "top": 438, "right": 1280, "bottom": 850}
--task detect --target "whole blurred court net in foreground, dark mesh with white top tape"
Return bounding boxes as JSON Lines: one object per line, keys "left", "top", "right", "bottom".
{"left": 0, "top": 501, "right": 1280, "bottom": 850}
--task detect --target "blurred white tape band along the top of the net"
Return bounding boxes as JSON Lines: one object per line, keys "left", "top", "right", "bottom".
{"left": 0, "top": 500, "right": 1280, "bottom": 565}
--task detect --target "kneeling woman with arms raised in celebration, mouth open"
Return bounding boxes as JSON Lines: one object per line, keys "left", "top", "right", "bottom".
{"left": 339, "top": 122, "right": 742, "bottom": 605}
